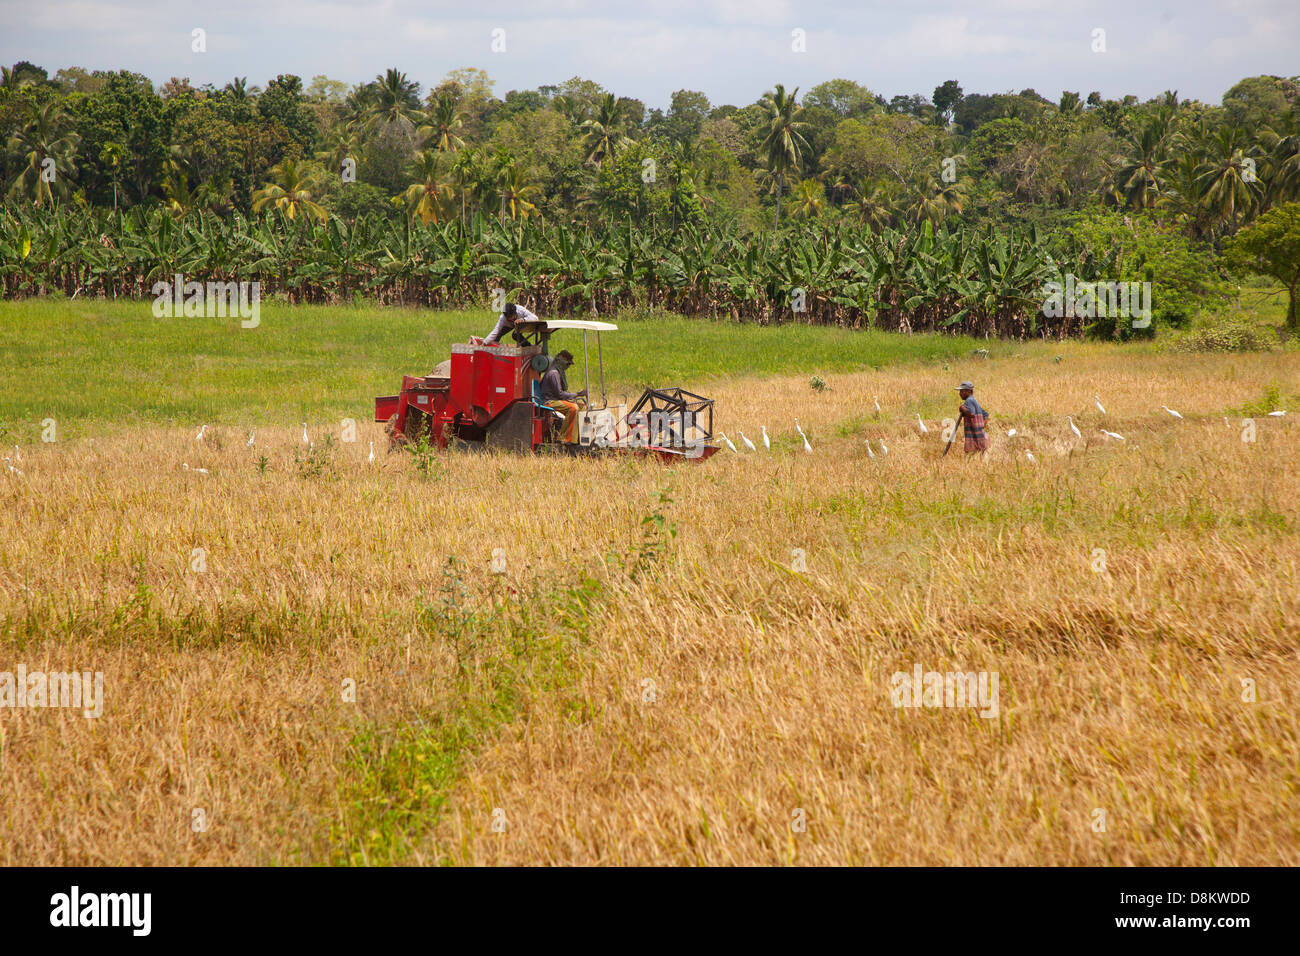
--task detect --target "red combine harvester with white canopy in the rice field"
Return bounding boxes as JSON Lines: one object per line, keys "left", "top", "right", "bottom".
{"left": 374, "top": 319, "right": 718, "bottom": 462}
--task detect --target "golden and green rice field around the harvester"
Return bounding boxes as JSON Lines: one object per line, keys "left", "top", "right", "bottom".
{"left": 0, "top": 302, "right": 1300, "bottom": 865}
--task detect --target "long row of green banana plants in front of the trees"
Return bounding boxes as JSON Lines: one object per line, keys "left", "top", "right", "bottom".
{"left": 0, "top": 196, "right": 1092, "bottom": 336}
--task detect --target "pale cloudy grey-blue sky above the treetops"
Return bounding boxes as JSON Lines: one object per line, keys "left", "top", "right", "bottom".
{"left": 0, "top": 0, "right": 1300, "bottom": 107}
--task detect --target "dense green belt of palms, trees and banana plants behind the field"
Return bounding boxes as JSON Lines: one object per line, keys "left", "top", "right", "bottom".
{"left": 0, "top": 62, "right": 1300, "bottom": 336}
